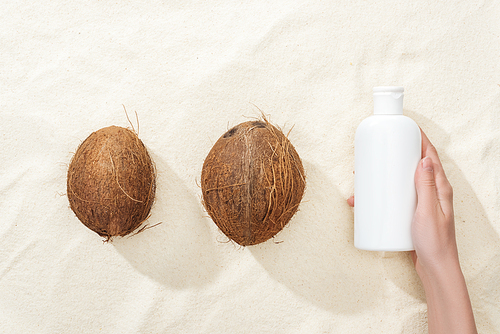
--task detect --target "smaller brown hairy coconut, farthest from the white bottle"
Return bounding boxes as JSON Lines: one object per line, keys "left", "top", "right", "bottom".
{"left": 67, "top": 126, "right": 156, "bottom": 241}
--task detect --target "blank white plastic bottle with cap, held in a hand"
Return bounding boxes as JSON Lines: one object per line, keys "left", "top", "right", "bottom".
{"left": 354, "top": 87, "right": 422, "bottom": 251}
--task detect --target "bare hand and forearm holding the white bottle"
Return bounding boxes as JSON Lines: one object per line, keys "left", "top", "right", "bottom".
{"left": 347, "top": 131, "right": 477, "bottom": 334}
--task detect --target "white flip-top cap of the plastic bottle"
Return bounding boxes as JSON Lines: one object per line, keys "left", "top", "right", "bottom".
{"left": 373, "top": 86, "right": 404, "bottom": 115}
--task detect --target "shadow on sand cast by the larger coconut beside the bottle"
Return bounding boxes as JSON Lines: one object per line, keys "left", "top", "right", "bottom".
{"left": 248, "top": 161, "right": 384, "bottom": 314}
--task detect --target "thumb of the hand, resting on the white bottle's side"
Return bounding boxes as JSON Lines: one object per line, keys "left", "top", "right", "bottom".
{"left": 415, "top": 157, "right": 439, "bottom": 210}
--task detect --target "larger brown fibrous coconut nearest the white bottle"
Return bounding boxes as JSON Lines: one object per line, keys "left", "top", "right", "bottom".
{"left": 201, "top": 119, "right": 306, "bottom": 246}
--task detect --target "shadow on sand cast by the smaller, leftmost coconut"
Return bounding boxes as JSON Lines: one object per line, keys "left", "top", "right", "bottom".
{"left": 113, "top": 154, "right": 220, "bottom": 289}
